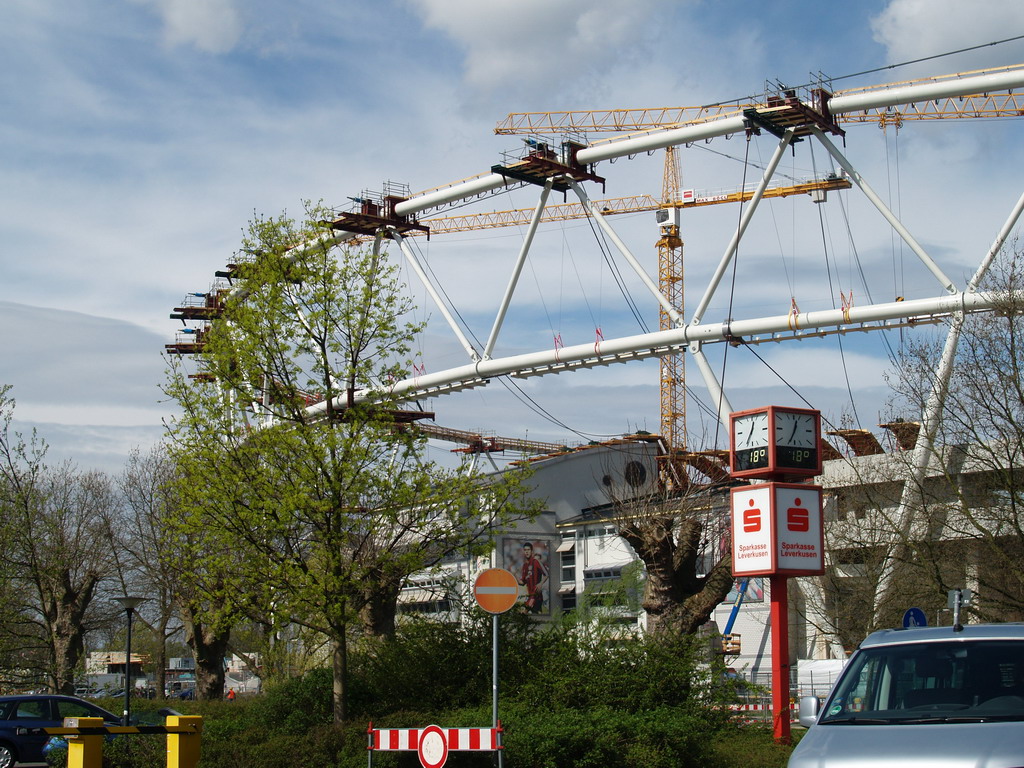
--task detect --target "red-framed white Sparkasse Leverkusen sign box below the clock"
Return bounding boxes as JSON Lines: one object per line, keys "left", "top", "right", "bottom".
{"left": 731, "top": 482, "right": 825, "bottom": 577}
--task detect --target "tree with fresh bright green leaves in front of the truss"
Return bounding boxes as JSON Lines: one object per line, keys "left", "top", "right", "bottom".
{"left": 168, "top": 204, "right": 532, "bottom": 721}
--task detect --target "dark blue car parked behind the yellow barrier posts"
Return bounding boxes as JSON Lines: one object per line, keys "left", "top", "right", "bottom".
{"left": 0, "top": 694, "right": 121, "bottom": 768}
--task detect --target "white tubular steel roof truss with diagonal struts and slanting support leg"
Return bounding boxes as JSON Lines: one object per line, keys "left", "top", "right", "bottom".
{"left": 186, "top": 68, "right": 1024, "bottom": 638}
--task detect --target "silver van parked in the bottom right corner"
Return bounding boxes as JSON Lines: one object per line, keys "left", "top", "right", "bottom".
{"left": 788, "top": 624, "right": 1024, "bottom": 768}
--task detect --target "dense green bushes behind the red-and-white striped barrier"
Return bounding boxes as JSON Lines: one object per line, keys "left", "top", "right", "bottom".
{"left": 51, "top": 613, "right": 790, "bottom": 768}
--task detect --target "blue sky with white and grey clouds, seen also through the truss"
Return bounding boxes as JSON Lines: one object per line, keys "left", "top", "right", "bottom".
{"left": 0, "top": 0, "right": 1024, "bottom": 473}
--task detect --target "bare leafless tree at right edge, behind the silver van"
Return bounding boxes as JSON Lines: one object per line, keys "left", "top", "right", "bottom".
{"left": 809, "top": 252, "right": 1024, "bottom": 648}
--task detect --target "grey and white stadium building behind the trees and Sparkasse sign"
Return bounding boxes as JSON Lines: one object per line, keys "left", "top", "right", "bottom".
{"left": 399, "top": 422, "right": 1011, "bottom": 688}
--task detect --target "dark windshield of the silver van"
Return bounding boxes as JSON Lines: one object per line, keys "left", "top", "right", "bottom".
{"left": 819, "top": 640, "right": 1024, "bottom": 725}
